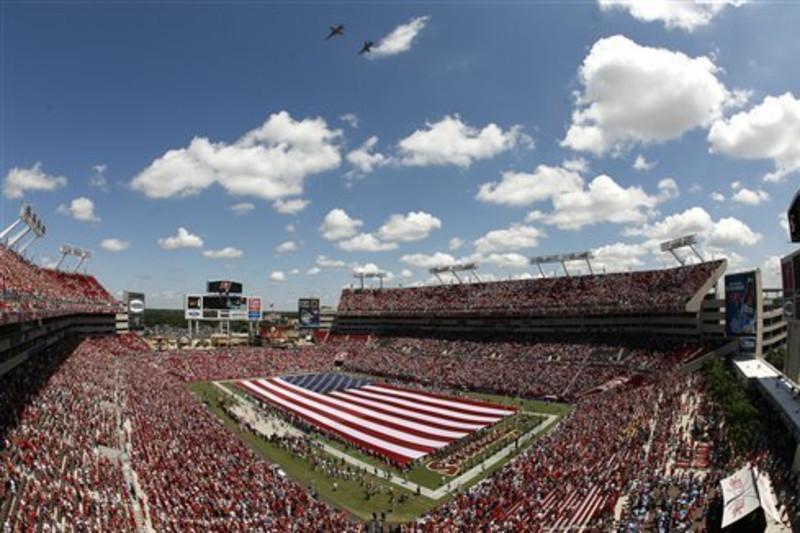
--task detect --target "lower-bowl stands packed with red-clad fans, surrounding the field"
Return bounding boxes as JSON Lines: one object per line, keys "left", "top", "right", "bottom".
{"left": 0, "top": 337, "right": 798, "bottom": 532}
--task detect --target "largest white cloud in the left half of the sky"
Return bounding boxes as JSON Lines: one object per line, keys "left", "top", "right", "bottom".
{"left": 131, "top": 111, "right": 341, "bottom": 200}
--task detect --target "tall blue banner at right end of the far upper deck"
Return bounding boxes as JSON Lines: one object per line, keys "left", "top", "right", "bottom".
{"left": 725, "top": 270, "right": 761, "bottom": 354}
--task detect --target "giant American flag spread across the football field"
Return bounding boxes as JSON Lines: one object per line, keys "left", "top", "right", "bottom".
{"left": 237, "top": 374, "right": 516, "bottom": 466}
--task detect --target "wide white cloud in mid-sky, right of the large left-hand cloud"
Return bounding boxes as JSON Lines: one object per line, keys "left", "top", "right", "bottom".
{"left": 398, "top": 115, "right": 533, "bottom": 168}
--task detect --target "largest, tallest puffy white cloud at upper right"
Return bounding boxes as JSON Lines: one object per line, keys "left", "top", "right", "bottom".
{"left": 561, "top": 35, "right": 741, "bottom": 155}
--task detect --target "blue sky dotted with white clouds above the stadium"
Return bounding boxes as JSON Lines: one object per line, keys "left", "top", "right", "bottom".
{"left": 0, "top": 0, "right": 800, "bottom": 309}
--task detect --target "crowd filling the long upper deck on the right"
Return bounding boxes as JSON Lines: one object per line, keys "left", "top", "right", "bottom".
{"left": 338, "top": 261, "right": 722, "bottom": 316}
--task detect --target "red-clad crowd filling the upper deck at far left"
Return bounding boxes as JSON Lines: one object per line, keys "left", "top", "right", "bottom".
{"left": 0, "top": 244, "right": 119, "bottom": 325}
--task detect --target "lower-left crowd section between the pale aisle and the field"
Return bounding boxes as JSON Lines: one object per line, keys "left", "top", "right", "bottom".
{"left": 124, "top": 344, "right": 350, "bottom": 531}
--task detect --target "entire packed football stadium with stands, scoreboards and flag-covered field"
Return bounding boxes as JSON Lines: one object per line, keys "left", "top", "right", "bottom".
{"left": 0, "top": 196, "right": 800, "bottom": 531}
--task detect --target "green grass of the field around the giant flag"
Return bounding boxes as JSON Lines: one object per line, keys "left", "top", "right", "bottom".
{"left": 188, "top": 382, "right": 570, "bottom": 523}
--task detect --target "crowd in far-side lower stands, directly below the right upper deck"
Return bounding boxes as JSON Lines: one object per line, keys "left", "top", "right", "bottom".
{"left": 338, "top": 338, "right": 703, "bottom": 400}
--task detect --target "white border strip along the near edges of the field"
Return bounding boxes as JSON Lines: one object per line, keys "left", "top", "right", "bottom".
{"left": 214, "top": 382, "right": 558, "bottom": 500}
